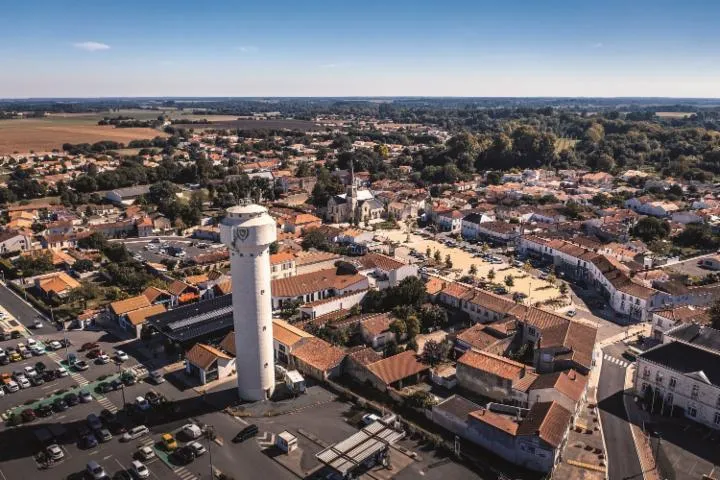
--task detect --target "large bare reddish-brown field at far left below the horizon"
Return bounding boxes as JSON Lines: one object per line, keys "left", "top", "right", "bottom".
{"left": 0, "top": 114, "right": 167, "bottom": 155}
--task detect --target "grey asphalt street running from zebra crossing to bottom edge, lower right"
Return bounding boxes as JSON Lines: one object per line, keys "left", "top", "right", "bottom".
{"left": 597, "top": 346, "right": 642, "bottom": 479}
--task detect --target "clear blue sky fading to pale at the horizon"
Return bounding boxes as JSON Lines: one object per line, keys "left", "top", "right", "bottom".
{"left": 0, "top": 0, "right": 720, "bottom": 98}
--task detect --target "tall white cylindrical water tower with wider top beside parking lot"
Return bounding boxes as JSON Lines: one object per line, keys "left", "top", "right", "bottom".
{"left": 220, "top": 204, "right": 277, "bottom": 401}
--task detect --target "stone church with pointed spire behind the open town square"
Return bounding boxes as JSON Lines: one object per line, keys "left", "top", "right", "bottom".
{"left": 325, "top": 164, "right": 385, "bottom": 224}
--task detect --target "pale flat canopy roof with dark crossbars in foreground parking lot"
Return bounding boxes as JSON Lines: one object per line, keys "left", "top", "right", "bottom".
{"left": 315, "top": 421, "right": 405, "bottom": 475}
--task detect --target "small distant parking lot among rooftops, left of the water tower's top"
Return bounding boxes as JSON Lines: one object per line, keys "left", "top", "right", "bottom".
{"left": 123, "top": 237, "right": 223, "bottom": 263}
